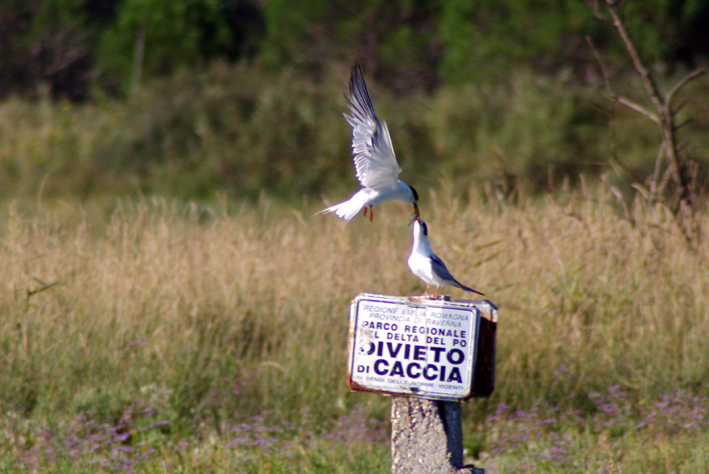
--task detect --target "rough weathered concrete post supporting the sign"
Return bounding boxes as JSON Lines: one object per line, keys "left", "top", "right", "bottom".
{"left": 391, "top": 397, "right": 485, "bottom": 474}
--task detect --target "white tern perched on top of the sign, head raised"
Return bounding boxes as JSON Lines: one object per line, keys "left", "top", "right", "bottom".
{"left": 409, "top": 219, "right": 485, "bottom": 298}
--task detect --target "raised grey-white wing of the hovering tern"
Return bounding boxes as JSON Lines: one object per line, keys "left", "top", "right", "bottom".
{"left": 345, "top": 61, "right": 401, "bottom": 188}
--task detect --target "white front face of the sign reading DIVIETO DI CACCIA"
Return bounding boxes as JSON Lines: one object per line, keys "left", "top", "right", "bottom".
{"left": 348, "top": 294, "right": 480, "bottom": 400}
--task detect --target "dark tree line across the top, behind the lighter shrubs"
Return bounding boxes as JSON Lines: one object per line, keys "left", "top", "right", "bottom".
{"left": 0, "top": 0, "right": 709, "bottom": 100}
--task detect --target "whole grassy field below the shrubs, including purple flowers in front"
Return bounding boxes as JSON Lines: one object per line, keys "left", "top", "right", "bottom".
{"left": 0, "top": 187, "right": 709, "bottom": 473}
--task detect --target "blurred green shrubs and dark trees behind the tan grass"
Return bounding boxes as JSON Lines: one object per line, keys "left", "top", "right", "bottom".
{"left": 0, "top": 0, "right": 709, "bottom": 200}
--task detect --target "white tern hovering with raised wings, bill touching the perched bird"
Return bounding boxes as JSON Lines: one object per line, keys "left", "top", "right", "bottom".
{"left": 318, "top": 61, "right": 419, "bottom": 222}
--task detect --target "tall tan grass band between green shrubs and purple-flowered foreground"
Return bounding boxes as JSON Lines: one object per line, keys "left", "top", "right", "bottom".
{"left": 0, "top": 186, "right": 709, "bottom": 470}
